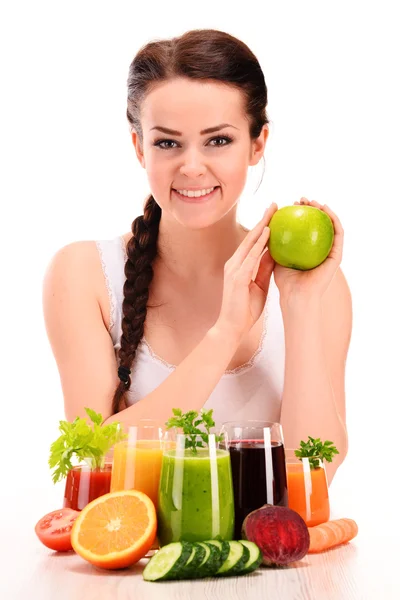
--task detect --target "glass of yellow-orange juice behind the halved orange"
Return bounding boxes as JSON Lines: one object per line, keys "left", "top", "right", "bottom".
{"left": 110, "top": 419, "right": 175, "bottom": 557}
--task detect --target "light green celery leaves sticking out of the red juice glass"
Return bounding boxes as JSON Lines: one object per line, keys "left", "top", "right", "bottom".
{"left": 48, "top": 408, "right": 127, "bottom": 483}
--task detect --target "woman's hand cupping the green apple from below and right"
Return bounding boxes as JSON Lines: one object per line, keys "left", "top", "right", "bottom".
{"left": 274, "top": 198, "right": 344, "bottom": 305}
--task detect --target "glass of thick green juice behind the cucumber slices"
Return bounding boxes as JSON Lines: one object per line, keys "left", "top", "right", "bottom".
{"left": 157, "top": 434, "right": 235, "bottom": 546}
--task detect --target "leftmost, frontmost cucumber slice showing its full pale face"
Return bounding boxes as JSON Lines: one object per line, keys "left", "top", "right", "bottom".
{"left": 143, "top": 542, "right": 193, "bottom": 581}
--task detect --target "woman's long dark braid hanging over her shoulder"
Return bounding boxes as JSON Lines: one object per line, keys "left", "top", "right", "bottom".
{"left": 112, "top": 196, "right": 161, "bottom": 414}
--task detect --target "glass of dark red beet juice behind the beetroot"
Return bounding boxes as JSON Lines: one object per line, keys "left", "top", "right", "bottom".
{"left": 220, "top": 421, "right": 288, "bottom": 540}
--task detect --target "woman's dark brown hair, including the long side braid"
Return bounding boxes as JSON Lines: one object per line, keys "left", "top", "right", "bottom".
{"left": 112, "top": 29, "right": 269, "bottom": 413}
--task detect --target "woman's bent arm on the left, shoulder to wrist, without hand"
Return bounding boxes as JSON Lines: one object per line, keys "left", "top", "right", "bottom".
{"left": 43, "top": 242, "right": 244, "bottom": 425}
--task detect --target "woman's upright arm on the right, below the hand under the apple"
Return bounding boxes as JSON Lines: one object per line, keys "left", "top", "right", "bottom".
{"left": 281, "top": 269, "right": 352, "bottom": 484}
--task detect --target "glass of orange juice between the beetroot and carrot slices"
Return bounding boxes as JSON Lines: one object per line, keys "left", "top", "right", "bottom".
{"left": 285, "top": 448, "right": 330, "bottom": 527}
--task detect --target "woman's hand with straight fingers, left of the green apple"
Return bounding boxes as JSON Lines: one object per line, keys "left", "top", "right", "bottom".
{"left": 215, "top": 202, "right": 278, "bottom": 338}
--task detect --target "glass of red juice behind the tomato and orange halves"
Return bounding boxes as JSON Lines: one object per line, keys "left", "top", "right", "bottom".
{"left": 63, "top": 456, "right": 111, "bottom": 510}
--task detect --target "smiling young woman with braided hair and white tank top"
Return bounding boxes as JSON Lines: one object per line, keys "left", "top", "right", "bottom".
{"left": 43, "top": 30, "right": 351, "bottom": 482}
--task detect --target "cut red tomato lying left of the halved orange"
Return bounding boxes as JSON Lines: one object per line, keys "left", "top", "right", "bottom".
{"left": 35, "top": 508, "right": 80, "bottom": 552}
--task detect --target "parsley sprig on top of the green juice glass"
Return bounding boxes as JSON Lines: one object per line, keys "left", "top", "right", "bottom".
{"left": 165, "top": 408, "right": 223, "bottom": 454}
